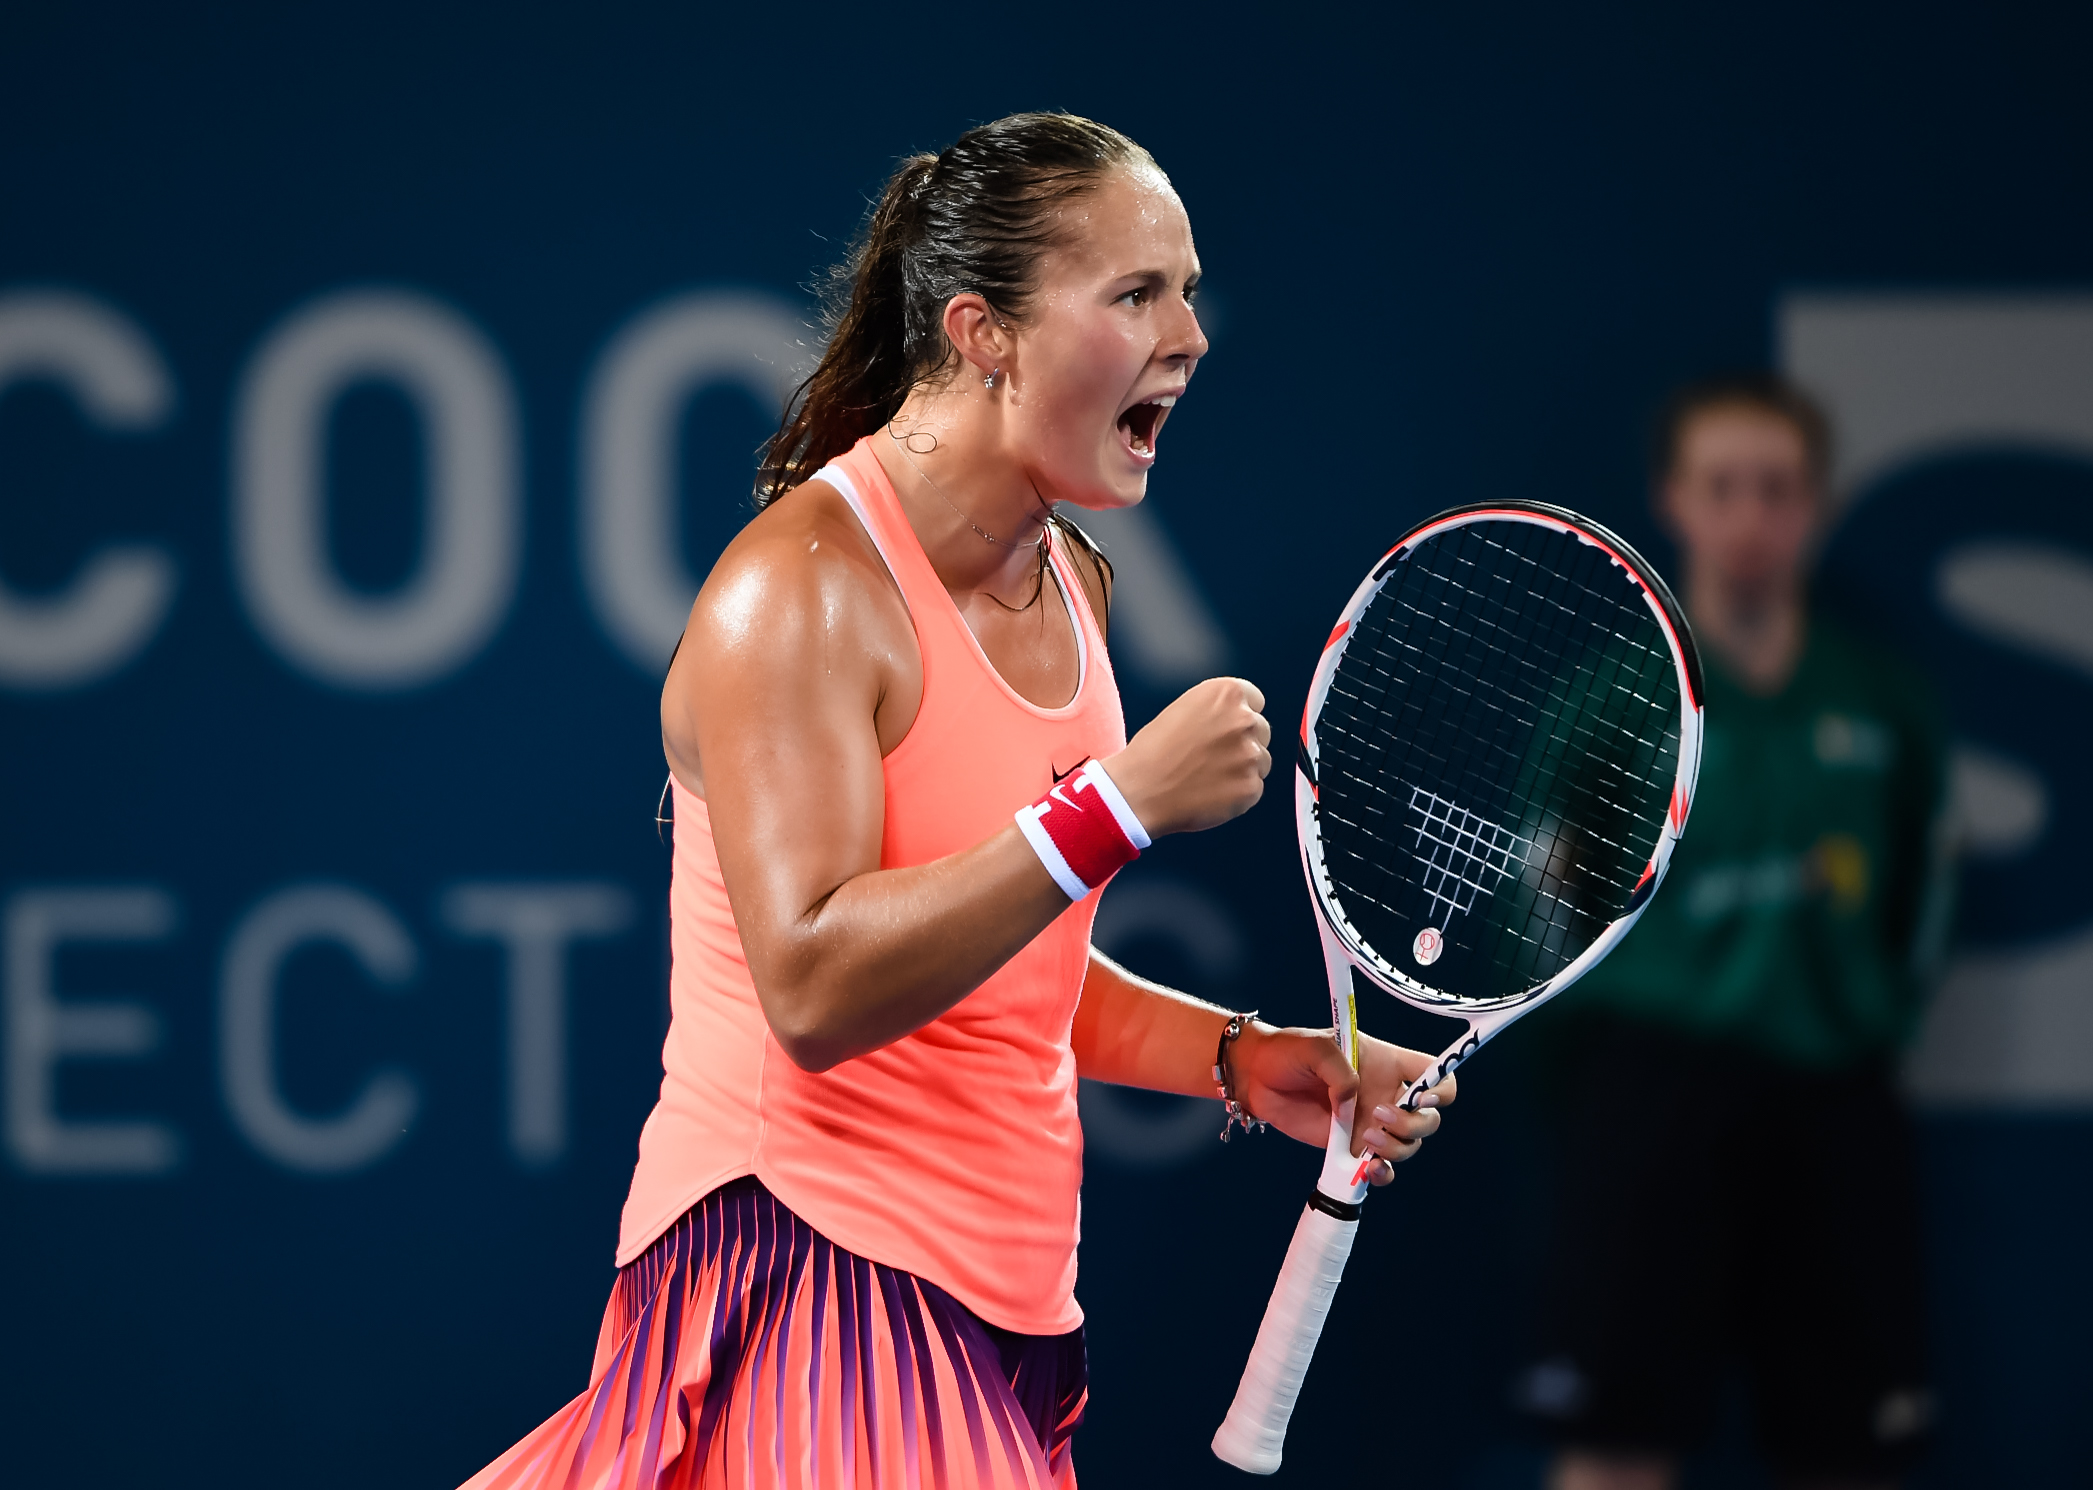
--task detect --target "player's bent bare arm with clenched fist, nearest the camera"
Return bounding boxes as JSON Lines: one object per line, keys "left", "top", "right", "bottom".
{"left": 663, "top": 504, "right": 1270, "bottom": 1071}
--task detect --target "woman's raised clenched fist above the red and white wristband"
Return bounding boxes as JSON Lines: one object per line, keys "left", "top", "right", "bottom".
{"left": 1105, "top": 678, "right": 1273, "bottom": 837}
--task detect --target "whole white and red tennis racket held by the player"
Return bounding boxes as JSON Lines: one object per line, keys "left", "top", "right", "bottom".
{"left": 1214, "top": 502, "right": 1702, "bottom": 1475}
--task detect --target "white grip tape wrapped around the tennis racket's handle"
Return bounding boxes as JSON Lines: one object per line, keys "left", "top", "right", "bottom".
{"left": 1214, "top": 1205, "right": 1358, "bottom": 1475}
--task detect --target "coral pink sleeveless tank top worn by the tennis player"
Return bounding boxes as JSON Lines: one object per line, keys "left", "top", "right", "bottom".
{"left": 617, "top": 439, "right": 1126, "bottom": 1335}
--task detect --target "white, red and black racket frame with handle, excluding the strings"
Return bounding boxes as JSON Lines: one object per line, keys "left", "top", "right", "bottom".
{"left": 1214, "top": 502, "right": 1706, "bottom": 1475}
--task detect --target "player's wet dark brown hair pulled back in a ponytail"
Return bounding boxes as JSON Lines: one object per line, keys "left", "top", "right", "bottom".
{"left": 756, "top": 113, "right": 1155, "bottom": 598}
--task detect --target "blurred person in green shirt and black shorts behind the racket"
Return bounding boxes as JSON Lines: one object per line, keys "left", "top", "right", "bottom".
{"left": 1517, "top": 375, "right": 1949, "bottom": 1490}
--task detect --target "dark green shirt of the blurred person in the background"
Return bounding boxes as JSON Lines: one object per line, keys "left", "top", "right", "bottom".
{"left": 1566, "top": 617, "right": 1949, "bottom": 1069}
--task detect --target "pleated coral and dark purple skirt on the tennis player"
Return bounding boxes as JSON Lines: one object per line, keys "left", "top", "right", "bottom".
{"left": 454, "top": 1178, "right": 1088, "bottom": 1490}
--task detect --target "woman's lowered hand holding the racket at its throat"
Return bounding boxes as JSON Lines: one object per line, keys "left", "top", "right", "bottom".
{"left": 1229, "top": 1023, "right": 1457, "bottom": 1184}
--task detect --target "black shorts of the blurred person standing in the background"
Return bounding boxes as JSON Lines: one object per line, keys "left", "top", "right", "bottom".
{"left": 1515, "top": 1017, "right": 1932, "bottom": 1477}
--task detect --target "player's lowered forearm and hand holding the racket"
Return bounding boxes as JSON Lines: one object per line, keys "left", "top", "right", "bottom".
{"left": 1072, "top": 946, "right": 1455, "bottom": 1184}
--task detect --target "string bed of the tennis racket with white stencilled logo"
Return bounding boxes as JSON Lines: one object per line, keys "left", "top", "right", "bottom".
{"left": 1316, "top": 523, "right": 1679, "bottom": 998}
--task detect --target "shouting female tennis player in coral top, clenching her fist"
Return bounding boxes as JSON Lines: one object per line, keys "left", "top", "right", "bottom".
{"left": 471, "top": 115, "right": 1453, "bottom": 1490}
